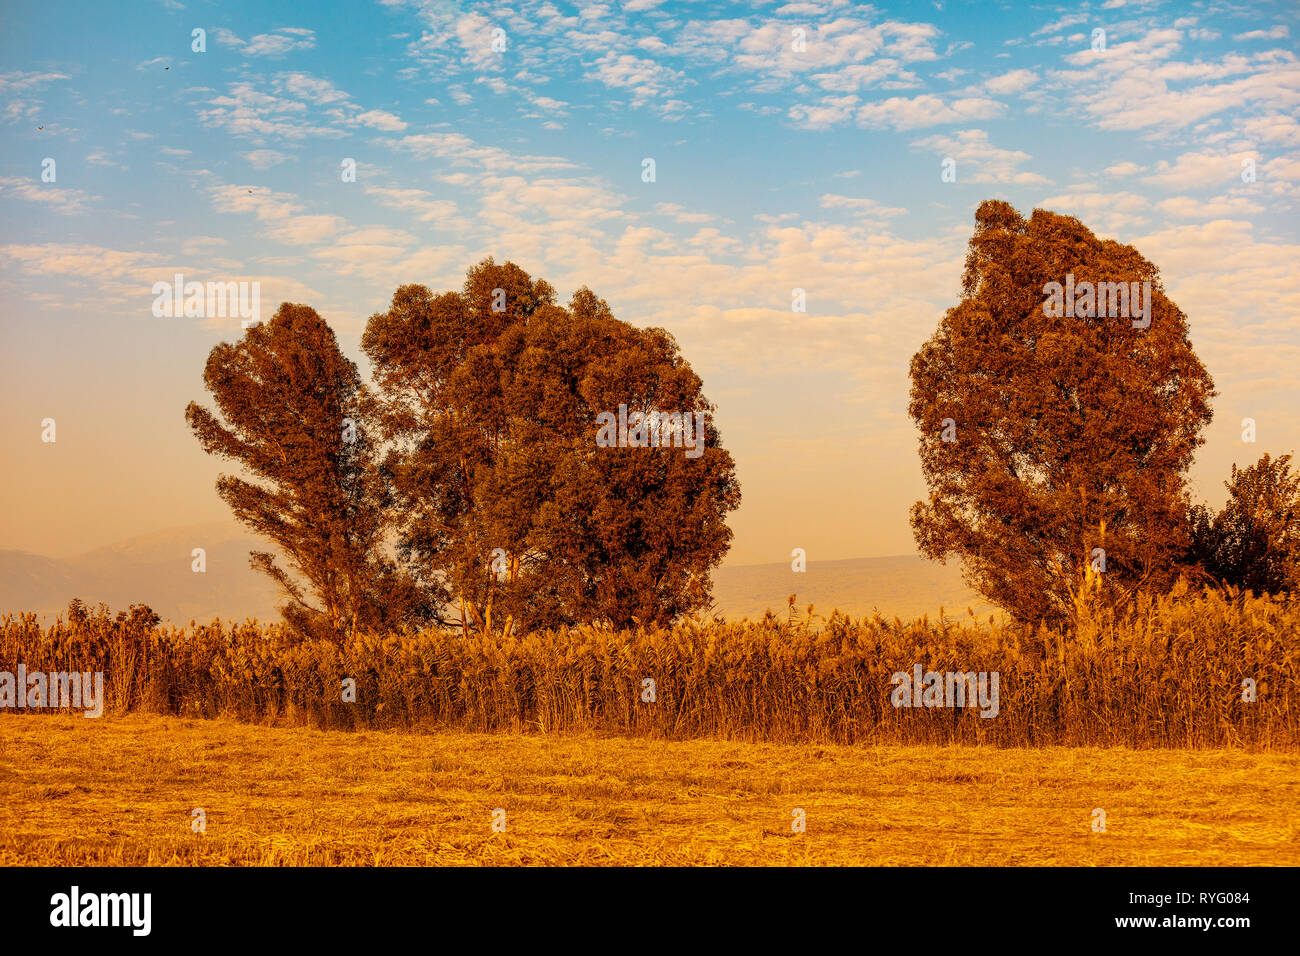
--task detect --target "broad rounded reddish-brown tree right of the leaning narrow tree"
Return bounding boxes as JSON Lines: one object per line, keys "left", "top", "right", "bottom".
{"left": 361, "top": 259, "right": 740, "bottom": 635}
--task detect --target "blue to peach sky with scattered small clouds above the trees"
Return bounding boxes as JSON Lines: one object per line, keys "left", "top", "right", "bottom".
{"left": 0, "top": 0, "right": 1300, "bottom": 564}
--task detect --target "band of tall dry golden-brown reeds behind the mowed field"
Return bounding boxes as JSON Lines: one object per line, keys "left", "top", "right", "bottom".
{"left": 0, "top": 591, "right": 1300, "bottom": 748}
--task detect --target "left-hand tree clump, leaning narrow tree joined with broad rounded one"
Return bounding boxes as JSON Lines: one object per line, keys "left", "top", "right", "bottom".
{"left": 186, "top": 259, "right": 740, "bottom": 639}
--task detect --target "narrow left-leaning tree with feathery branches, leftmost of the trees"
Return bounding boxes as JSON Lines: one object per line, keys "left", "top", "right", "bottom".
{"left": 185, "top": 302, "right": 437, "bottom": 640}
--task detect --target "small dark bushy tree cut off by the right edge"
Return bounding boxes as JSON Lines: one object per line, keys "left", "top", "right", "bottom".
{"left": 1190, "top": 454, "right": 1300, "bottom": 594}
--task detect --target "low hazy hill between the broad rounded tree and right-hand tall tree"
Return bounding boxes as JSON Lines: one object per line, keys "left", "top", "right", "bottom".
{"left": 714, "top": 554, "right": 995, "bottom": 620}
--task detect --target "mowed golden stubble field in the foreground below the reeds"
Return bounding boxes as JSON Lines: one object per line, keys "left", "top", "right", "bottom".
{"left": 0, "top": 715, "right": 1300, "bottom": 865}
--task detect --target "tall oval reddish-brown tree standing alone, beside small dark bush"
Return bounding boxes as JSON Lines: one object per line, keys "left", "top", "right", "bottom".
{"left": 909, "top": 200, "right": 1214, "bottom": 620}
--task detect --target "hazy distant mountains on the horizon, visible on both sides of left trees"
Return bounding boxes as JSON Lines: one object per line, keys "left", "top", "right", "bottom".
{"left": 0, "top": 524, "right": 993, "bottom": 624}
